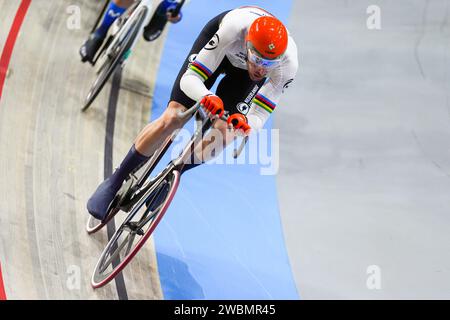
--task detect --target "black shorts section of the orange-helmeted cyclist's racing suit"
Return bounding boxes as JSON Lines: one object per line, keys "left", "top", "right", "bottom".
{"left": 170, "top": 11, "right": 265, "bottom": 114}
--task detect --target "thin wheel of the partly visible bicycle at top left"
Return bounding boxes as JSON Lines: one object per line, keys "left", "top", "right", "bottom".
{"left": 81, "top": 7, "right": 147, "bottom": 112}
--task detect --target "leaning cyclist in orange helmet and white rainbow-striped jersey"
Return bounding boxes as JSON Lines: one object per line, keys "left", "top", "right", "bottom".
{"left": 87, "top": 6, "right": 298, "bottom": 220}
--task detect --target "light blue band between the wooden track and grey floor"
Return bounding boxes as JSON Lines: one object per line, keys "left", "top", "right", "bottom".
{"left": 152, "top": 0, "right": 299, "bottom": 300}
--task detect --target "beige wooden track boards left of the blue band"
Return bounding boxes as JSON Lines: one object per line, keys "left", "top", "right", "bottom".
{"left": 0, "top": 0, "right": 169, "bottom": 299}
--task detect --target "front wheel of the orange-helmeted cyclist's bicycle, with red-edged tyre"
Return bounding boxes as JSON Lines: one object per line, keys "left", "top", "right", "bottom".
{"left": 91, "top": 170, "right": 180, "bottom": 288}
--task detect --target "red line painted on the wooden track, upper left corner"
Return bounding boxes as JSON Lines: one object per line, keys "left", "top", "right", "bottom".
{"left": 0, "top": 0, "right": 31, "bottom": 100}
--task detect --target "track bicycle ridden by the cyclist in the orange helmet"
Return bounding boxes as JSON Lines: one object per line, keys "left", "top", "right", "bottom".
{"left": 86, "top": 103, "right": 248, "bottom": 288}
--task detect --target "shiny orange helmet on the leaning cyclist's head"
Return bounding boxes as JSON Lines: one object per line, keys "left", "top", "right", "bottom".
{"left": 245, "top": 16, "right": 288, "bottom": 60}
